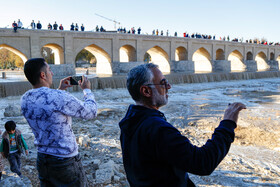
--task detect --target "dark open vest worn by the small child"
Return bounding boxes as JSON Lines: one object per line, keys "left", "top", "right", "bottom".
{"left": 2, "top": 129, "right": 23, "bottom": 158}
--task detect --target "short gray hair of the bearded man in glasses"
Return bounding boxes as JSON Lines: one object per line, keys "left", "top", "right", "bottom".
{"left": 126, "top": 63, "right": 158, "bottom": 101}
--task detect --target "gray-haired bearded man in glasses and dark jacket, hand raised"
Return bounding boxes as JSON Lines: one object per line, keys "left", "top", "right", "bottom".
{"left": 119, "top": 63, "right": 246, "bottom": 187}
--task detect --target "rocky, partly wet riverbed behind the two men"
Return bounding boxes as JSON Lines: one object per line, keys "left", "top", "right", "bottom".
{"left": 0, "top": 78, "right": 280, "bottom": 186}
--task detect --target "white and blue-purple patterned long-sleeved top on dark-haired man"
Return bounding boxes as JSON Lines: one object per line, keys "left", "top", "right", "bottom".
{"left": 21, "top": 87, "right": 97, "bottom": 157}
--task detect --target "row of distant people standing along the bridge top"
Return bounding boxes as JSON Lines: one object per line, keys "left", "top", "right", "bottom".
{"left": 6, "top": 19, "right": 280, "bottom": 45}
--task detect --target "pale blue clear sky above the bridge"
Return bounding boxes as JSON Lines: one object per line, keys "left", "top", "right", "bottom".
{"left": 0, "top": 0, "right": 280, "bottom": 42}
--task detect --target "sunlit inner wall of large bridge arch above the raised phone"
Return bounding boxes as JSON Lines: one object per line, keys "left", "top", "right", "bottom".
{"left": 75, "top": 44, "right": 112, "bottom": 75}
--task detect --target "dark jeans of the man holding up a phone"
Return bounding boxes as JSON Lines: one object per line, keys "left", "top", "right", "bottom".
{"left": 37, "top": 152, "right": 88, "bottom": 187}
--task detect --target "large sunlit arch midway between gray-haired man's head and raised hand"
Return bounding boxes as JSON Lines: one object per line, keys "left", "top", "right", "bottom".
{"left": 192, "top": 47, "right": 212, "bottom": 72}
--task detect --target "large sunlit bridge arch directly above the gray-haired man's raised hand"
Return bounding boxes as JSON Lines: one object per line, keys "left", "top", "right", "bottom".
{"left": 228, "top": 50, "right": 246, "bottom": 71}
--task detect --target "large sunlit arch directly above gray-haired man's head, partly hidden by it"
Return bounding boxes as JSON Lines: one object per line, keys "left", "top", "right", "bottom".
{"left": 146, "top": 46, "right": 170, "bottom": 73}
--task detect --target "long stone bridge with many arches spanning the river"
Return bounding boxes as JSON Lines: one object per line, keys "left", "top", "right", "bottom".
{"left": 0, "top": 29, "right": 280, "bottom": 74}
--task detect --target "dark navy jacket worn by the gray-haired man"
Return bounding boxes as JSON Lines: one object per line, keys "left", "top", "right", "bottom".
{"left": 119, "top": 105, "right": 236, "bottom": 187}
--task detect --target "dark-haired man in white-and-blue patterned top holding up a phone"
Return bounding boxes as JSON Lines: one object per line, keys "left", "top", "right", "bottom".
{"left": 21, "top": 58, "right": 97, "bottom": 186}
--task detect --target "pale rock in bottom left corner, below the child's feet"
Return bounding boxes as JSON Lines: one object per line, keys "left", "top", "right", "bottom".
{"left": 0, "top": 174, "right": 32, "bottom": 187}
